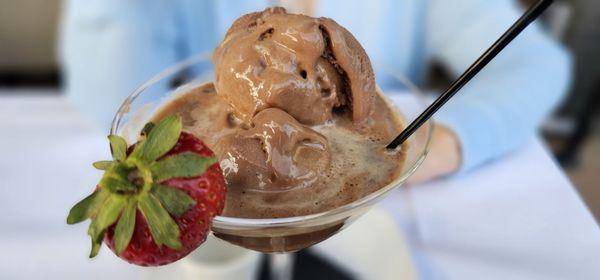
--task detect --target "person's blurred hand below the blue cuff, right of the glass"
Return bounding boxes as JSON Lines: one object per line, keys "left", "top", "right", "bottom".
{"left": 407, "top": 124, "right": 462, "bottom": 185}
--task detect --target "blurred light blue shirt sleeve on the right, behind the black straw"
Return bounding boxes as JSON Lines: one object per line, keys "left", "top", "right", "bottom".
{"left": 425, "top": 0, "right": 571, "bottom": 172}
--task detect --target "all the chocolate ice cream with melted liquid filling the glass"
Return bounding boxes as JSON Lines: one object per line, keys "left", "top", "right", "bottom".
{"left": 154, "top": 8, "right": 407, "bottom": 222}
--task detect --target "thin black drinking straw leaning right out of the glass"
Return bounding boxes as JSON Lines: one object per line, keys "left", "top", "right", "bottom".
{"left": 386, "top": 0, "right": 553, "bottom": 149}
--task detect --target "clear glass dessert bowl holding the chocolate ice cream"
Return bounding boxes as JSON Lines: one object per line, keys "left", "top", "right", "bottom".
{"left": 110, "top": 54, "right": 432, "bottom": 253}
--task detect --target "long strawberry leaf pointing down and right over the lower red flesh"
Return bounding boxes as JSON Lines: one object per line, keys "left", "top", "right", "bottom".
{"left": 139, "top": 193, "right": 182, "bottom": 250}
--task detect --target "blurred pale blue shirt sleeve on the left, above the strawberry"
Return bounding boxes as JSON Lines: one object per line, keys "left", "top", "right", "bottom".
{"left": 60, "top": 0, "right": 180, "bottom": 129}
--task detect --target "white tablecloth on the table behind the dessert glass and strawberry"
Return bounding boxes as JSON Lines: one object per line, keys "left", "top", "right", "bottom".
{"left": 0, "top": 95, "right": 600, "bottom": 279}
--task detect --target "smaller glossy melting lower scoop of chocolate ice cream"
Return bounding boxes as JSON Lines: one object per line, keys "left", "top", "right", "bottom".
{"left": 216, "top": 108, "right": 330, "bottom": 190}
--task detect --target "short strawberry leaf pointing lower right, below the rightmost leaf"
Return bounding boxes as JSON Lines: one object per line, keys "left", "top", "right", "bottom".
{"left": 152, "top": 185, "right": 196, "bottom": 217}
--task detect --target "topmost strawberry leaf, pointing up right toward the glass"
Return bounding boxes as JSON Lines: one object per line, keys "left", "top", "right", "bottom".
{"left": 131, "top": 115, "right": 182, "bottom": 163}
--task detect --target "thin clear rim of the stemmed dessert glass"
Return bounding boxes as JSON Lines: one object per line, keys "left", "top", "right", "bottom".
{"left": 110, "top": 53, "right": 433, "bottom": 229}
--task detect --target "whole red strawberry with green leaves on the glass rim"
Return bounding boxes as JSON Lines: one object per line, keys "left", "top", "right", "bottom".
{"left": 67, "top": 116, "right": 225, "bottom": 266}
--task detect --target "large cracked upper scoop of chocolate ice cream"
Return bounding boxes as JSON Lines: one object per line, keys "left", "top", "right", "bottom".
{"left": 213, "top": 8, "right": 375, "bottom": 125}
